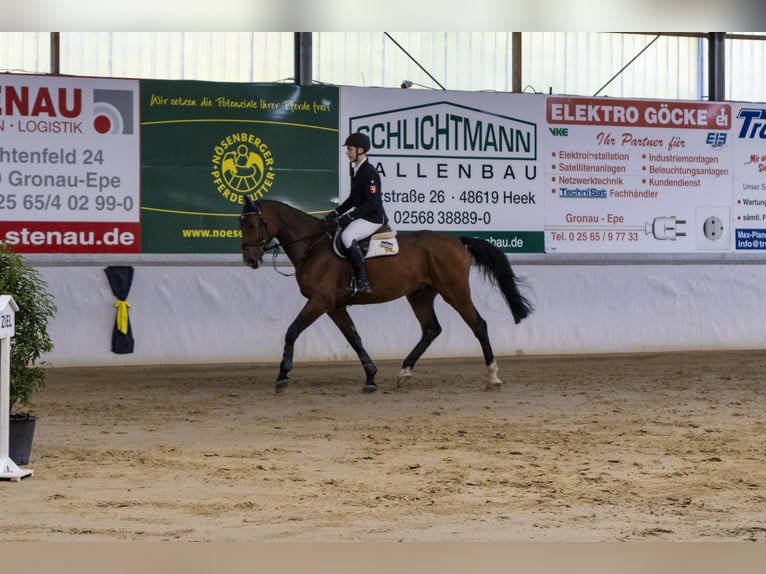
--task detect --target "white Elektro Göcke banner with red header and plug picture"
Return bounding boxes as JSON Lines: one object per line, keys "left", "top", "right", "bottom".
{"left": 544, "top": 96, "right": 732, "bottom": 253}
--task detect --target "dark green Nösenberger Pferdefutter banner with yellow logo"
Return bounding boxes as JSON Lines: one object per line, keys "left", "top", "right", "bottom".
{"left": 141, "top": 80, "right": 341, "bottom": 253}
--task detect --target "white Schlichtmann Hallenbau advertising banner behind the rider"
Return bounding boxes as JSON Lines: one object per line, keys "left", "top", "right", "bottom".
{"left": 339, "top": 88, "right": 545, "bottom": 253}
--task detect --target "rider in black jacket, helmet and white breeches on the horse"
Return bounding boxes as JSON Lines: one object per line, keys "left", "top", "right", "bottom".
{"left": 325, "top": 132, "right": 388, "bottom": 293}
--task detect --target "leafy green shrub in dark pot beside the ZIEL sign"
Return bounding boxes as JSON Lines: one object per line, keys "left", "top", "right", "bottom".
{"left": 0, "top": 242, "right": 57, "bottom": 465}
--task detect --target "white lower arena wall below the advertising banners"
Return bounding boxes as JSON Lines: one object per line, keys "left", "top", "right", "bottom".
{"left": 39, "top": 263, "right": 766, "bottom": 374}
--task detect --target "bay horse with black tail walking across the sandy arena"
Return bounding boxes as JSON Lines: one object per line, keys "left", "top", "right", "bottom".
{"left": 239, "top": 198, "right": 532, "bottom": 393}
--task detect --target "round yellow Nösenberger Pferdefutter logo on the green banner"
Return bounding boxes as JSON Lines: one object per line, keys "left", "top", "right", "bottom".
{"left": 211, "top": 132, "right": 275, "bottom": 204}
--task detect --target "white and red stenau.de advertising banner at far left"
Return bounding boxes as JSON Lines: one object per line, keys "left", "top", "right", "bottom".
{"left": 0, "top": 74, "right": 141, "bottom": 253}
